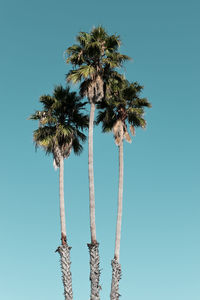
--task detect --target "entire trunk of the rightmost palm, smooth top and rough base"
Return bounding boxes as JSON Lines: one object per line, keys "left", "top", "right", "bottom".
{"left": 110, "top": 134, "right": 124, "bottom": 300}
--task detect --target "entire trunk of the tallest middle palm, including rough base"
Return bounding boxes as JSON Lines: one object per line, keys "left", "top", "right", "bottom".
{"left": 88, "top": 102, "right": 101, "bottom": 300}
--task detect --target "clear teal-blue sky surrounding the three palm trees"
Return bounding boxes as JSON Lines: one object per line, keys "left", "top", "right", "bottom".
{"left": 0, "top": 0, "right": 200, "bottom": 300}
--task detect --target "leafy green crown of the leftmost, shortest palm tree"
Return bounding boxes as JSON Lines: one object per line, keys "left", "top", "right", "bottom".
{"left": 30, "top": 86, "right": 88, "bottom": 167}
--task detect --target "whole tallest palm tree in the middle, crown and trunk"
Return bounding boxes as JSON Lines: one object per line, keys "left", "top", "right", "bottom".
{"left": 66, "top": 26, "right": 130, "bottom": 300}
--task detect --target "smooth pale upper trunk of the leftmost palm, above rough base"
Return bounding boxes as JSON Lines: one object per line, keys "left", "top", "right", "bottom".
{"left": 59, "top": 156, "right": 67, "bottom": 245}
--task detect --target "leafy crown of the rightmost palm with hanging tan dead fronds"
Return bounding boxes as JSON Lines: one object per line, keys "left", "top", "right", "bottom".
{"left": 96, "top": 75, "right": 151, "bottom": 142}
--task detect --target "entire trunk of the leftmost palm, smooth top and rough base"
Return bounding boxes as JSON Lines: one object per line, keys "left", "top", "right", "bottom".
{"left": 56, "top": 156, "right": 73, "bottom": 300}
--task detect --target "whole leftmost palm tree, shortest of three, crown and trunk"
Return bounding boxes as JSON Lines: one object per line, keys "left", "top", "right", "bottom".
{"left": 30, "top": 86, "right": 88, "bottom": 300}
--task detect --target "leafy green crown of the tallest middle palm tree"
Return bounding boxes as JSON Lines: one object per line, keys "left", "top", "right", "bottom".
{"left": 66, "top": 26, "right": 130, "bottom": 103}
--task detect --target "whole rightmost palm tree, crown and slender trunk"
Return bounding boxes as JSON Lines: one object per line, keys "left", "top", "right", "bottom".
{"left": 96, "top": 80, "right": 151, "bottom": 300}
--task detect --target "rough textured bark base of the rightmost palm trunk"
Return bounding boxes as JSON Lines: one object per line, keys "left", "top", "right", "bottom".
{"left": 110, "top": 259, "right": 121, "bottom": 300}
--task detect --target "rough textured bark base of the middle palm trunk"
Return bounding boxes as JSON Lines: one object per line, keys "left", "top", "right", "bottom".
{"left": 88, "top": 243, "right": 101, "bottom": 300}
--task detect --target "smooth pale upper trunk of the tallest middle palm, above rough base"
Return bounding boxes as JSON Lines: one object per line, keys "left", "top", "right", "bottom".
{"left": 88, "top": 103, "right": 96, "bottom": 244}
